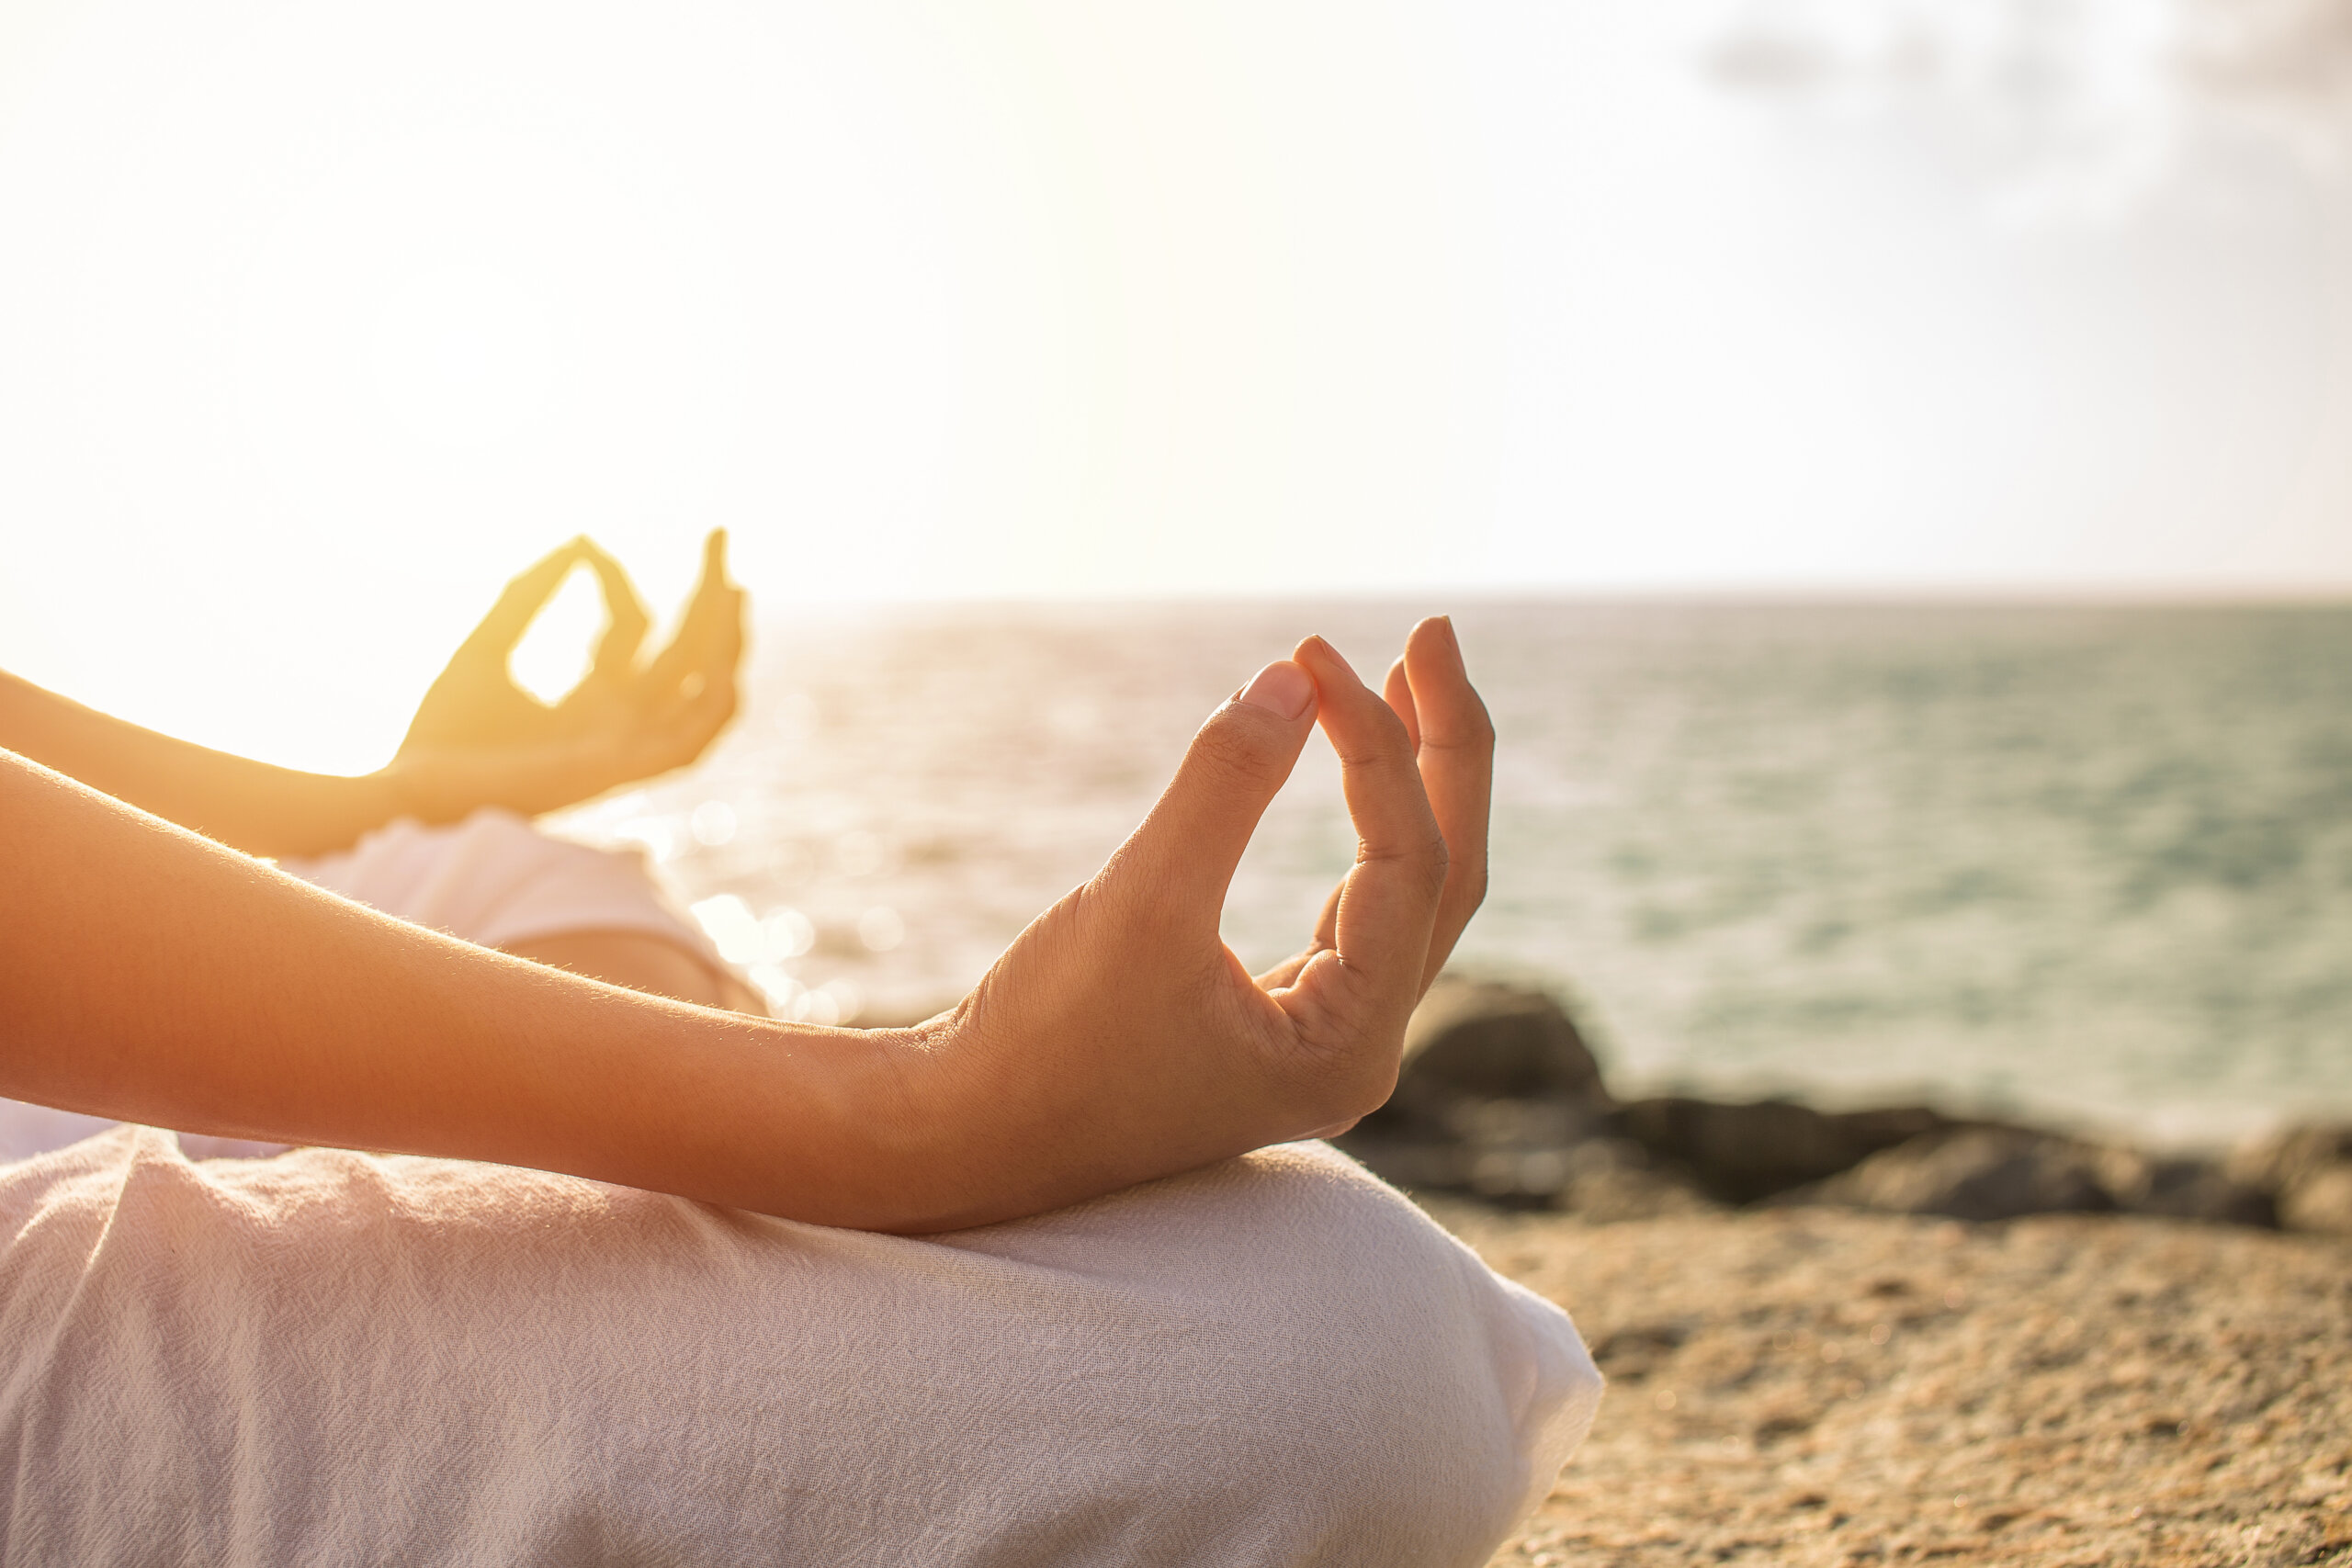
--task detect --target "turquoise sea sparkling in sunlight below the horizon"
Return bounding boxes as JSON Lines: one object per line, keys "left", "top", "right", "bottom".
{"left": 555, "top": 604, "right": 2352, "bottom": 1140}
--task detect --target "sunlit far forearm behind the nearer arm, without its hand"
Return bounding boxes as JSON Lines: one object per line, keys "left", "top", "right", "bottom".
{"left": 0, "top": 672, "right": 404, "bottom": 856}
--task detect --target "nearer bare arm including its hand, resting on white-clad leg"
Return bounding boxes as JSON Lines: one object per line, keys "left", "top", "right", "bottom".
{"left": 0, "top": 621, "right": 1491, "bottom": 1232}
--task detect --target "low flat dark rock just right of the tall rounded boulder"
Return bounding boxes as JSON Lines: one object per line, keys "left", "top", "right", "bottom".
{"left": 1616, "top": 1096, "right": 1954, "bottom": 1203}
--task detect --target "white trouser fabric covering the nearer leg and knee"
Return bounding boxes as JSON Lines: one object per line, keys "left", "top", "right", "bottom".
{"left": 0, "top": 1128, "right": 1600, "bottom": 1568}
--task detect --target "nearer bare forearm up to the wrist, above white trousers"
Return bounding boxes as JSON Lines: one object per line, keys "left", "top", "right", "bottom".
{"left": 0, "top": 757, "right": 962, "bottom": 1229}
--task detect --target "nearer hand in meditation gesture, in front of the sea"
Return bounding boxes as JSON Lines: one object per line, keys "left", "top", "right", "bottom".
{"left": 917, "top": 618, "right": 1494, "bottom": 1227}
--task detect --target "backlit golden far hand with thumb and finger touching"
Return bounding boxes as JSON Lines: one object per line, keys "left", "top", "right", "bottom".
{"left": 388, "top": 531, "right": 743, "bottom": 820}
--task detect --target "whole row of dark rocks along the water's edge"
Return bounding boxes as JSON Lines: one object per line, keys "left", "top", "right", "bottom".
{"left": 1336, "top": 976, "right": 2295, "bottom": 1235}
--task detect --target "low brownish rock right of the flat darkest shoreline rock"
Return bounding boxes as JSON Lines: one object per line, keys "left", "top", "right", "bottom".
{"left": 1804, "top": 1126, "right": 2114, "bottom": 1220}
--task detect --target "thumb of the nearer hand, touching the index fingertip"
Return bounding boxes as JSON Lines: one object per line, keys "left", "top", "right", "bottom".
{"left": 1101, "top": 659, "right": 1315, "bottom": 929}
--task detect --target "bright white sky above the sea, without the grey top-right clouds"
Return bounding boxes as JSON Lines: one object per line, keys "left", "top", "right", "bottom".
{"left": 0, "top": 0, "right": 2352, "bottom": 766}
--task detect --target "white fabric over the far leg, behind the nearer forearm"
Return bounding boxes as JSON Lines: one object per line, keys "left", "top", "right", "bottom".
{"left": 0, "top": 807, "right": 729, "bottom": 1159}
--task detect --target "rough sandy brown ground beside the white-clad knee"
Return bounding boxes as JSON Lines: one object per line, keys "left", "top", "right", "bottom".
{"left": 1432, "top": 1201, "right": 2352, "bottom": 1568}
